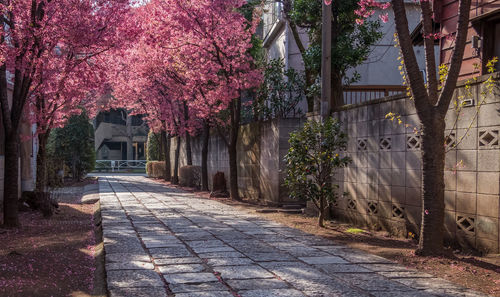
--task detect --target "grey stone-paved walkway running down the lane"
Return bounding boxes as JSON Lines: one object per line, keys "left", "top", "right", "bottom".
{"left": 99, "top": 175, "right": 488, "bottom": 297}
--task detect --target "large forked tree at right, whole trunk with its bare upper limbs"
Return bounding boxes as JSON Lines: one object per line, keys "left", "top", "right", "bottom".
{"left": 392, "top": 0, "right": 471, "bottom": 256}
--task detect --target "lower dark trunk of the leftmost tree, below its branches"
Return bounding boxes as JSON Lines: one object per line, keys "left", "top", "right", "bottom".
{"left": 3, "top": 129, "right": 20, "bottom": 227}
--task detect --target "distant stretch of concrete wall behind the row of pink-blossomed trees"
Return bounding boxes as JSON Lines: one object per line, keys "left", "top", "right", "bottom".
{"left": 170, "top": 119, "right": 303, "bottom": 204}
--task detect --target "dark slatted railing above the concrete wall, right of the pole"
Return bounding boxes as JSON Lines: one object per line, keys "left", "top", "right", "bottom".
{"left": 344, "top": 85, "right": 406, "bottom": 105}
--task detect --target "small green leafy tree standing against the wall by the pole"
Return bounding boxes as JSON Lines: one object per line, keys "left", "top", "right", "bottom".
{"left": 285, "top": 118, "right": 351, "bottom": 227}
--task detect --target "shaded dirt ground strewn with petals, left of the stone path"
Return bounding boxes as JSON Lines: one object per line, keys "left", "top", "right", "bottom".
{"left": 0, "top": 203, "right": 105, "bottom": 297}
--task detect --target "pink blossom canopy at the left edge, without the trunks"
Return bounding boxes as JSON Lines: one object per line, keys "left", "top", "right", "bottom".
{"left": 0, "top": 0, "right": 131, "bottom": 133}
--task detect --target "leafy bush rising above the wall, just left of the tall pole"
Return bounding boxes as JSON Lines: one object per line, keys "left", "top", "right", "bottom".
{"left": 253, "top": 59, "right": 305, "bottom": 120}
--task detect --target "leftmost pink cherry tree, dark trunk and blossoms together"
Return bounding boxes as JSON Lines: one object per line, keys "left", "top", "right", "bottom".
{"left": 0, "top": 0, "right": 128, "bottom": 227}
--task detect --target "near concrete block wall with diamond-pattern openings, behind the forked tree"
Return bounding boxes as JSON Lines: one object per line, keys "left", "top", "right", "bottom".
{"left": 333, "top": 73, "right": 500, "bottom": 253}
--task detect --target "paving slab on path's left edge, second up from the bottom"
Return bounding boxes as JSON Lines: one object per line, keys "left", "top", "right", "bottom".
{"left": 106, "top": 270, "right": 164, "bottom": 289}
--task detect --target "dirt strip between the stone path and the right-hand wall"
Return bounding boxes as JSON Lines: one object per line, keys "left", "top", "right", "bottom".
{"left": 158, "top": 180, "right": 500, "bottom": 297}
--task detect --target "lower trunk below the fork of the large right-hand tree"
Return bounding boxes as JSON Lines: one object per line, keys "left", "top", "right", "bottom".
{"left": 416, "top": 118, "right": 446, "bottom": 256}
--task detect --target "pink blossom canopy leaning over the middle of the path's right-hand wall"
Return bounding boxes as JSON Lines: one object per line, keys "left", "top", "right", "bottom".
{"left": 106, "top": 0, "right": 261, "bottom": 135}
